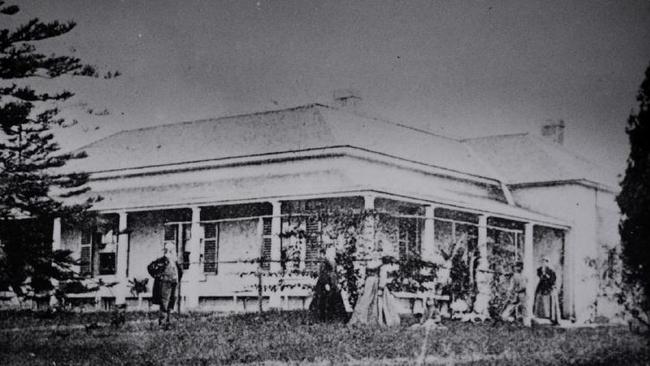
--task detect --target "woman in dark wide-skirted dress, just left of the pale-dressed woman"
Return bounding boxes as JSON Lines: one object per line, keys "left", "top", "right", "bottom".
{"left": 309, "top": 247, "right": 348, "bottom": 321}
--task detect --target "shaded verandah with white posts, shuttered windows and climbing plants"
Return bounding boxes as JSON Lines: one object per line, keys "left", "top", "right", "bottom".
{"left": 53, "top": 190, "right": 574, "bottom": 324}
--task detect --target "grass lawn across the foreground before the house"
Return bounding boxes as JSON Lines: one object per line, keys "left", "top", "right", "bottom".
{"left": 0, "top": 312, "right": 650, "bottom": 366}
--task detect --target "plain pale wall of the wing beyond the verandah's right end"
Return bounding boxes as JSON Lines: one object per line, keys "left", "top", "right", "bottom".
{"left": 512, "top": 184, "right": 618, "bottom": 322}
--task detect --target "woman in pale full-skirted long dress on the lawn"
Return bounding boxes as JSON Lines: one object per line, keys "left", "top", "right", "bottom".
{"left": 348, "top": 257, "right": 400, "bottom": 326}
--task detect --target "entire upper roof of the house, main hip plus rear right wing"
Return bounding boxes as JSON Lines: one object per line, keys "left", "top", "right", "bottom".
{"left": 66, "top": 104, "right": 617, "bottom": 188}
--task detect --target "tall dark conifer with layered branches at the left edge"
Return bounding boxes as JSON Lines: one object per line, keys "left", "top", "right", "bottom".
{"left": 0, "top": 1, "right": 107, "bottom": 300}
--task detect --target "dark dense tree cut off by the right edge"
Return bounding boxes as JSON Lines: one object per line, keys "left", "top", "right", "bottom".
{"left": 617, "top": 62, "right": 650, "bottom": 322}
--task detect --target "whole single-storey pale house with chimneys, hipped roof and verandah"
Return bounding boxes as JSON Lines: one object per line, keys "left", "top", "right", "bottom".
{"left": 53, "top": 95, "right": 619, "bottom": 322}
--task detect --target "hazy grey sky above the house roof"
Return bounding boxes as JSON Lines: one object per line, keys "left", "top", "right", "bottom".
{"left": 11, "top": 0, "right": 650, "bottom": 183}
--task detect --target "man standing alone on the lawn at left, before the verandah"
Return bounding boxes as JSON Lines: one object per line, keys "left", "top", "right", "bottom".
{"left": 147, "top": 246, "right": 183, "bottom": 327}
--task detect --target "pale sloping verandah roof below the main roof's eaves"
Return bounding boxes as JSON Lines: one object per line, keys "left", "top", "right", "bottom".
{"left": 82, "top": 173, "right": 570, "bottom": 228}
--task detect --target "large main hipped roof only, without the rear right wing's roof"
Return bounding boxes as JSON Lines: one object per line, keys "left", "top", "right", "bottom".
{"left": 69, "top": 104, "right": 494, "bottom": 178}
